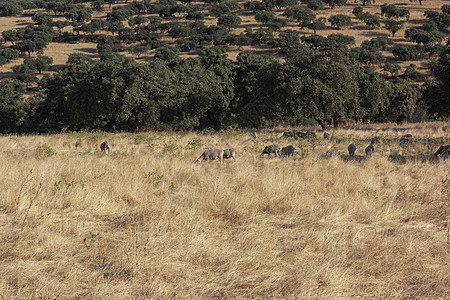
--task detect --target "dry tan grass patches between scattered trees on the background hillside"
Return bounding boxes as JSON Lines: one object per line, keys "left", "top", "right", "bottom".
{"left": 0, "top": 0, "right": 448, "bottom": 79}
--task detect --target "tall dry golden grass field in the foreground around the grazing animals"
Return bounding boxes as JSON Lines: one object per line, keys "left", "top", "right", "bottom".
{"left": 0, "top": 122, "right": 450, "bottom": 299}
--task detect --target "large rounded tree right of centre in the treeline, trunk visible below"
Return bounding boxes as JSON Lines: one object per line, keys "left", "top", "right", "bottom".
{"left": 279, "top": 47, "right": 361, "bottom": 128}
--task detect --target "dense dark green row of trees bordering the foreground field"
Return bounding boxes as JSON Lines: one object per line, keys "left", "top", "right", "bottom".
{"left": 0, "top": 45, "right": 450, "bottom": 133}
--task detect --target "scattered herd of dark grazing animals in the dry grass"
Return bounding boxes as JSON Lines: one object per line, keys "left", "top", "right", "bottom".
{"left": 100, "top": 130, "right": 450, "bottom": 163}
